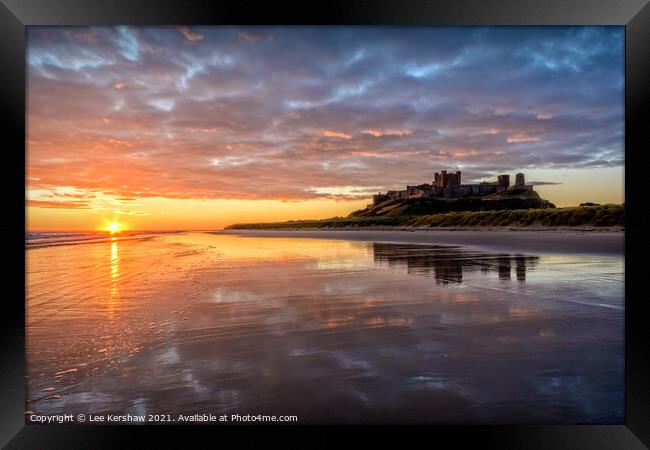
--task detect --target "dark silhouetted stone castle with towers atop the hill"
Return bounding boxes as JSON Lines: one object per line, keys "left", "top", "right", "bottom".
{"left": 368, "top": 170, "right": 533, "bottom": 206}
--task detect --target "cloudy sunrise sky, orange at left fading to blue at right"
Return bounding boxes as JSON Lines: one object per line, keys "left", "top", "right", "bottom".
{"left": 26, "top": 26, "right": 624, "bottom": 230}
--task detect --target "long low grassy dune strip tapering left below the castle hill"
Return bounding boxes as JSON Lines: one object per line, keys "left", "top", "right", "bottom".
{"left": 226, "top": 204, "right": 625, "bottom": 230}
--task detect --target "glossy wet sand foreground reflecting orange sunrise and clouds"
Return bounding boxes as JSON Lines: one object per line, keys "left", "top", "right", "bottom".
{"left": 26, "top": 231, "right": 624, "bottom": 423}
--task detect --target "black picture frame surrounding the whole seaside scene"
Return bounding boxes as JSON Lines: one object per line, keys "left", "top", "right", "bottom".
{"left": 0, "top": 0, "right": 650, "bottom": 449}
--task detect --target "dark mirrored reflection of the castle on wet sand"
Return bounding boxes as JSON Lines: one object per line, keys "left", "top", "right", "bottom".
{"left": 372, "top": 242, "right": 539, "bottom": 284}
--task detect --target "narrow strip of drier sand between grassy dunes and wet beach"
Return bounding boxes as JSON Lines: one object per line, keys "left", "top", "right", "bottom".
{"left": 218, "top": 227, "right": 625, "bottom": 256}
